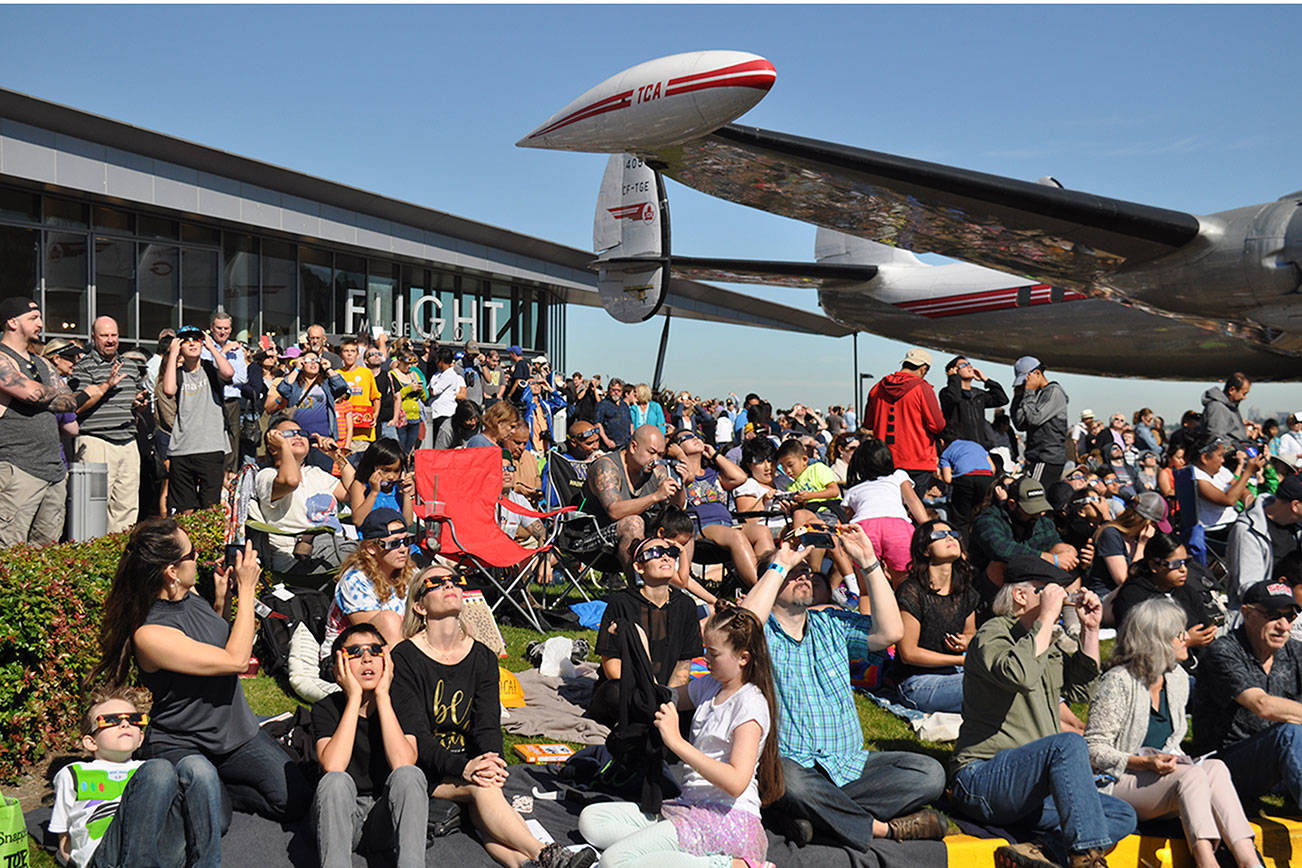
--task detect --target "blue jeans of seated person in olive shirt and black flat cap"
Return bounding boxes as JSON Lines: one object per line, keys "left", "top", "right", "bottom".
{"left": 952, "top": 733, "right": 1135, "bottom": 864}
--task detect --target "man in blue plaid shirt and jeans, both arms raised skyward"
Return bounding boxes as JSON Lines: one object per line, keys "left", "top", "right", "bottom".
{"left": 743, "top": 524, "right": 948, "bottom": 858}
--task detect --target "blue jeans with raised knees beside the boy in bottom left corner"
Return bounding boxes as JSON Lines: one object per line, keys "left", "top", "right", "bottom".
{"left": 90, "top": 756, "right": 221, "bottom": 868}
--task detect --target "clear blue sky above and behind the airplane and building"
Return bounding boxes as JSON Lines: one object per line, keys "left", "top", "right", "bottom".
{"left": 0, "top": 5, "right": 1302, "bottom": 420}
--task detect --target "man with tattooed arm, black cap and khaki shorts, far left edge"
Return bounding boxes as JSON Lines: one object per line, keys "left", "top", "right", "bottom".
{"left": 0, "top": 297, "right": 122, "bottom": 545}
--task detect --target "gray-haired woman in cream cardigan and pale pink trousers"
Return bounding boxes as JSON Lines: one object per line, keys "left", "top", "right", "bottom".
{"left": 1085, "top": 597, "right": 1262, "bottom": 868}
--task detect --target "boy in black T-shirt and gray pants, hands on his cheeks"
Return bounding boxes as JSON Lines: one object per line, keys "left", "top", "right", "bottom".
{"left": 311, "top": 624, "right": 430, "bottom": 868}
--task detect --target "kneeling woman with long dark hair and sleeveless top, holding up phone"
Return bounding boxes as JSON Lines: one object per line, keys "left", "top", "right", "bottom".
{"left": 90, "top": 518, "right": 311, "bottom": 820}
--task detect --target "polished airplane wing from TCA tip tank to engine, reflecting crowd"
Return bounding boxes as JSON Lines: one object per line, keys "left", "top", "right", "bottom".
{"left": 639, "top": 124, "right": 1199, "bottom": 295}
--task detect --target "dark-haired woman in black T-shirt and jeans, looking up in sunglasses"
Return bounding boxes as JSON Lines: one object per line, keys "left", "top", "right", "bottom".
{"left": 891, "top": 519, "right": 980, "bottom": 713}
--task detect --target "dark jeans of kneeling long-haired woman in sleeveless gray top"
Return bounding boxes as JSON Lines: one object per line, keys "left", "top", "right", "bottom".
{"left": 140, "top": 730, "right": 312, "bottom": 832}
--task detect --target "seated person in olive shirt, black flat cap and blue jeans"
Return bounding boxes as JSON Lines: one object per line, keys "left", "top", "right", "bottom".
{"left": 950, "top": 556, "right": 1135, "bottom": 868}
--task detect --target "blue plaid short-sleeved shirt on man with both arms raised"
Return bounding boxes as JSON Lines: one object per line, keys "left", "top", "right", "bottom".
{"left": 764, "top": 609, "right": 887, "bottom": 786}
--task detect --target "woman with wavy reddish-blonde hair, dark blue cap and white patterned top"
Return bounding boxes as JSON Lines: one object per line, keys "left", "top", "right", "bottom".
{"left": 322, "top": 506, "right": 415, "bottom": 661}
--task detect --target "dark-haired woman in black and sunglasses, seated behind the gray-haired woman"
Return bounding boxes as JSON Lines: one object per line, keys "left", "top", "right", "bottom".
{"left": 1112, "top": 532, "right": 1225, "bottom": 656}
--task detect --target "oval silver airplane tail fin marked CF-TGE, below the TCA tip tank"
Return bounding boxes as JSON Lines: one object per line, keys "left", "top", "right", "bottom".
{"left": 592, "top": 154, "right": 669, "bottom": 323}
